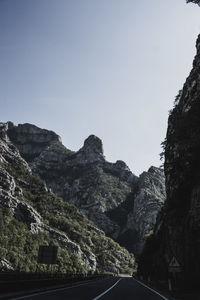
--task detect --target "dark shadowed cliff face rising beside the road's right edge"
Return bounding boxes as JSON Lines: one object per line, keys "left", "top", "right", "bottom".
{"left": 139, "top": 36, "right": 200, "bottom": 287}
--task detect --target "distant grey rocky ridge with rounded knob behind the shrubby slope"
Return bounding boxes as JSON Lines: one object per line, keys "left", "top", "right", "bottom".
{"left": 5, "top": 122, "right": 165, "bottom": 254}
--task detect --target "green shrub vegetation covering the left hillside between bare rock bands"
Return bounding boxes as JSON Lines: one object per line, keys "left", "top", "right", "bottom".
{"left": 0, "top": 158, "right": 135, "bottom": 274}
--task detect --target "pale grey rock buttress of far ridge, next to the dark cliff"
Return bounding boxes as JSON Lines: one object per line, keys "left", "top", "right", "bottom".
{"left": 120, "top": 167, "right": 166, "bottom": 255}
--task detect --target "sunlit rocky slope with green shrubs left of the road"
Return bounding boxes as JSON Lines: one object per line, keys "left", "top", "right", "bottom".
{"left": 0, "top": 123, "right": 134, "bottom": 274}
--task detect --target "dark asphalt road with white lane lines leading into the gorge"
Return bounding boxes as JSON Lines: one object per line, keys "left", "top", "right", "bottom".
{"left": 12, "top": 277, "right": 168, "bottom": 300}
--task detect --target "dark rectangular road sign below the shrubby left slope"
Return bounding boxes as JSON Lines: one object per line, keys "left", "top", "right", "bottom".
{"left": 38, "top": 246, "right": 58, "bottom": 265}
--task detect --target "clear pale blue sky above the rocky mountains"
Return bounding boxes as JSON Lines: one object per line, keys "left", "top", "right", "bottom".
{"left": 0, "top": 0, "right": 200, "bottom": 175}
